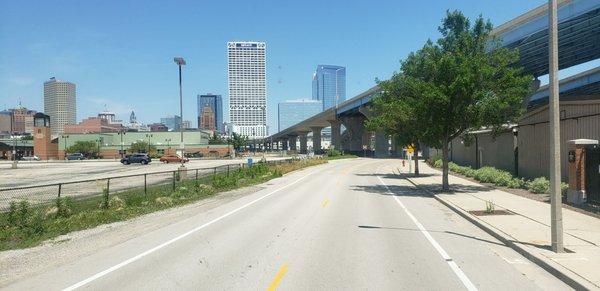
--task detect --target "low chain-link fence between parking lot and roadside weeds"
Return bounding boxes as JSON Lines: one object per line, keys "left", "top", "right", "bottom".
{"left": 0, "top": 159, "right": 290, "bottom": 211}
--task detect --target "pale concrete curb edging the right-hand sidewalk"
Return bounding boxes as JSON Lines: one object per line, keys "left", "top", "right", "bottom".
{"left": 400, "top": 173, "right": 599, "bottom": 290}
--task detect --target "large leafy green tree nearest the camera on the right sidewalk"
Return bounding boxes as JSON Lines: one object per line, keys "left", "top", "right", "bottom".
{"left": 380, "top": 11, "right": 533, "bottom": 191}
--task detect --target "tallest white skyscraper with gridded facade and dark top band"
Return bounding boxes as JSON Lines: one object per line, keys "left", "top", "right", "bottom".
{"left": 227, "top": 41, "right": 268, "bottom": 138}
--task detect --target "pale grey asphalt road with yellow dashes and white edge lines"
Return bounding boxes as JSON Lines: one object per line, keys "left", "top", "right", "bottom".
{"left": 4, "top": 159, "right": 569, "bottom": 290}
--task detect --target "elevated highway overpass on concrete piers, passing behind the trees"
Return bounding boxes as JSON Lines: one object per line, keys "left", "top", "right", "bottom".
{"left": 262, "top": 0, "right": 600, "bottom": 157}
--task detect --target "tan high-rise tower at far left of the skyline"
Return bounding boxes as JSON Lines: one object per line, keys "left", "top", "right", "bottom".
{"left": 44, "top": 77, "right": 77, "bottom": 136}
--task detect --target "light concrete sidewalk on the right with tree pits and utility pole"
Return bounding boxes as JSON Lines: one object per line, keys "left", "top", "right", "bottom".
{"left": 397, "top": 162, "right": 600, "bottom": 290}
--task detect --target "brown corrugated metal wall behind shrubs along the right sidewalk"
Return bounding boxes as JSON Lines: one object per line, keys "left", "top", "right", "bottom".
{"left": 430, "top": 100, "right": 600, "bottom": 181}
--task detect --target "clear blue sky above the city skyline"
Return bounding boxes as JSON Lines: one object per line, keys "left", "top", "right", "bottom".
{"left": 0, "top": 0, "right": 596, "bottom": 132}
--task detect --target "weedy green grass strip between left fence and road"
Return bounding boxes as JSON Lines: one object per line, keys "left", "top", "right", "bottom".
{"left": 0, "top": 158, "right": 327, "bottom": 251}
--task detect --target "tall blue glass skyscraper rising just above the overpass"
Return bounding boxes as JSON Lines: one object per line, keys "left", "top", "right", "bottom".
{"left": 312, "top": 65, "right": 346, "bottom": 110}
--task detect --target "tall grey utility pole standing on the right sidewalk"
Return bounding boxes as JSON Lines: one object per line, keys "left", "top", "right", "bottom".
{"left": 548, "top": 0, "right": 564, "bottom": 253}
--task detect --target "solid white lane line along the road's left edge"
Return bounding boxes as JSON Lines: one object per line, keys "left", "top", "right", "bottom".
{"left": 63, "top": 167, "right": 324, "bottom": 291}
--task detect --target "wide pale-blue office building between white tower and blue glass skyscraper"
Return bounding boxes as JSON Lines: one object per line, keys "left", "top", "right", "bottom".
{"left": 277, "top": 99, "right": 323, "bottom": 131}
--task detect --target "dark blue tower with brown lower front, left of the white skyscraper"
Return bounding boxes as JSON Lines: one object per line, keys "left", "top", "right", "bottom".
{"left": 198, "top": 93, "right": 225, "bottom": 133}
